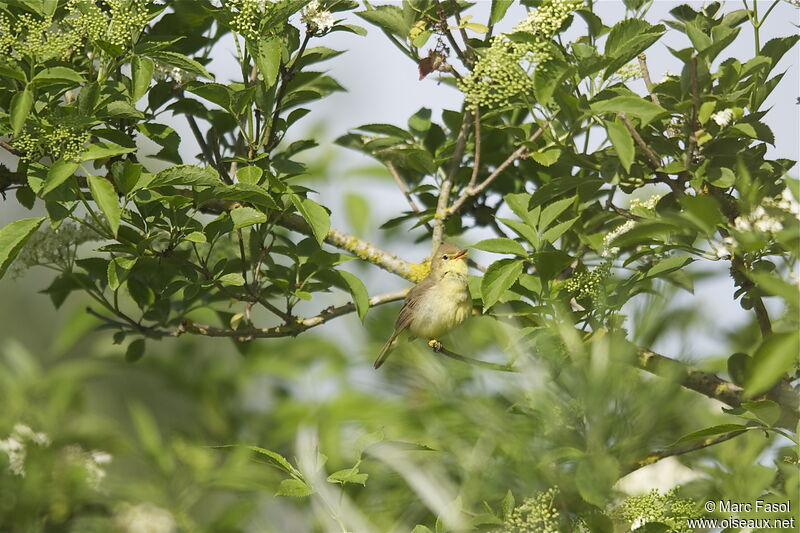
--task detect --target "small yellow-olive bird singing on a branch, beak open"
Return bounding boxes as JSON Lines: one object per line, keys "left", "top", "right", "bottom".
{"left": 375, "top": 242, "right": 472, "bottom": 368}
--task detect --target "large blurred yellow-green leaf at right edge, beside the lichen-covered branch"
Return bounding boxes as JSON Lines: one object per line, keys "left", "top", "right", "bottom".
{"left": 744, "top": 331, "right": 800, "bottom": 398}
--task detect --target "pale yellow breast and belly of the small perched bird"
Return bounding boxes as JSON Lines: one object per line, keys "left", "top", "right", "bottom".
{"left": 409, "top": 275, "right": 472, "bottom": 339}
